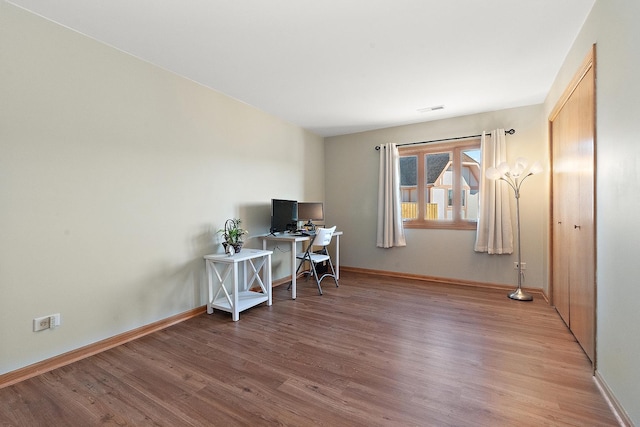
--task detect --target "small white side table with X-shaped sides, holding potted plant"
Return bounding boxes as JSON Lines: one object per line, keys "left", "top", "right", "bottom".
{"left": 204, "top": 249, "right": 273, "bottom": 322}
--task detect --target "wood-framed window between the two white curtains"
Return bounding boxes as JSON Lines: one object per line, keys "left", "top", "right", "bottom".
{"left": 399, "top": 139, "right": 481, "bottom": 229}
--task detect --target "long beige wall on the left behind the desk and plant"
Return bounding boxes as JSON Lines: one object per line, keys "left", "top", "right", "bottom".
{"left": 0, "top": 1, "right": 324, "bottom": 374}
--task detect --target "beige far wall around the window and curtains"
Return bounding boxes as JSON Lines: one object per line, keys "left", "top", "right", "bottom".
{"left": 326, "top": 105, "right": 549, "bottom": 290}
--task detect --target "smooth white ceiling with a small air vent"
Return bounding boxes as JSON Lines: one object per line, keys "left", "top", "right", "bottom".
{"left": 9, "top": 0, "right": 595, "bottom": 136}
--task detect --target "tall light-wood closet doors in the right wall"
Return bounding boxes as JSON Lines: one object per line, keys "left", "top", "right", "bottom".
{"left": 550, "top": 47, "right": 596, "bottom": 368}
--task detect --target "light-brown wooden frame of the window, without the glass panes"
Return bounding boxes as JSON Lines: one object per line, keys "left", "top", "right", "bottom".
{"left": 398, "top": 138, "right": 482, "bottom": 230}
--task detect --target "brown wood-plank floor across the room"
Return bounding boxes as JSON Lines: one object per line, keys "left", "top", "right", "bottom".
{"left": 0, "top": 272, "right": 618, "bottom": 426}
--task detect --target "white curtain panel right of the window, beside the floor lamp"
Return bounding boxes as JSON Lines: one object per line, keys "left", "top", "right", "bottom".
{"left": 474, "top": 129, "right": 513, "bottom": 254}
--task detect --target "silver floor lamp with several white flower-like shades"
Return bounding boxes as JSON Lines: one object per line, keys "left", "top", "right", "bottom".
{"left": 485, "top": 157, "right": 542, "bottom": 301}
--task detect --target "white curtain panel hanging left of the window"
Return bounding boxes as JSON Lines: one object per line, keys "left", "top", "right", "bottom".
{"left": 376, "top": 143, "right": 407, "bottom": 248}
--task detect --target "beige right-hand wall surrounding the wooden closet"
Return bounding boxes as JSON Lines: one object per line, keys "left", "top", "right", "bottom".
{"left": 545, "top": 0, "right": 640, "bottom": 425}
